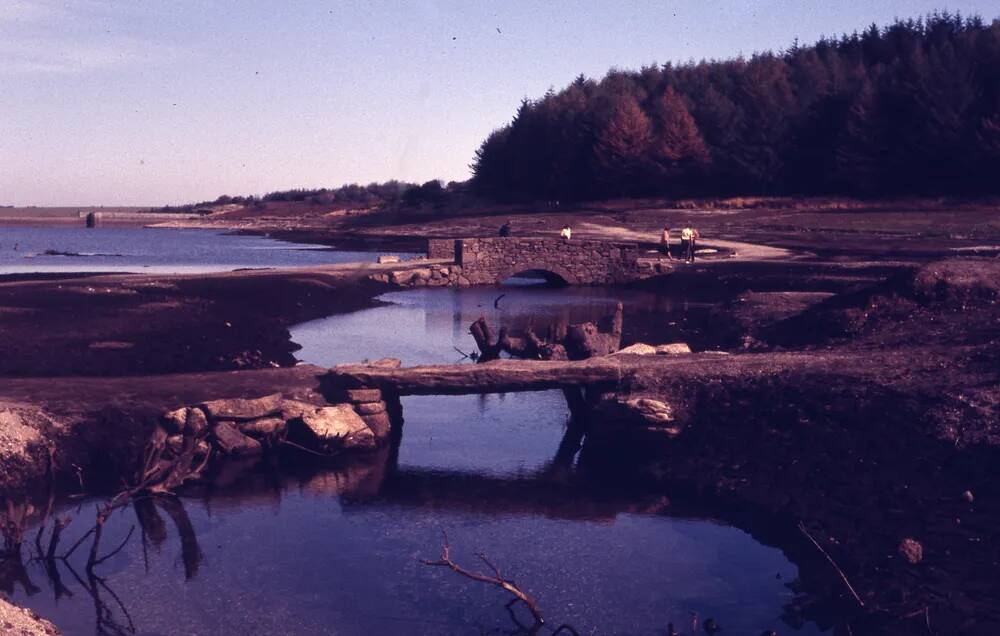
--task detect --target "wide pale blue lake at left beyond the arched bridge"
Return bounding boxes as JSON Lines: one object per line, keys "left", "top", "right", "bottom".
{"left": 0, "top": 227, "right": 414, "bottom": 275}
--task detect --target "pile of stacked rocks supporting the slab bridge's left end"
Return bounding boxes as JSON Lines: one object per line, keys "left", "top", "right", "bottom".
{"left": 157, "top": 389, "right": 391, "bottom": 459}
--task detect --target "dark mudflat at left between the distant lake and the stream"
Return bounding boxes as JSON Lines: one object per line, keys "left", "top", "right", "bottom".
{"left": 0, "top": 265, "right": 446, "bottom": 377}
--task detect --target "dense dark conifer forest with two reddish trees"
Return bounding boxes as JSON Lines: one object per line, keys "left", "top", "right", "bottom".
{"left": 472, "top": 13, "right": 1000, "bottom": 200}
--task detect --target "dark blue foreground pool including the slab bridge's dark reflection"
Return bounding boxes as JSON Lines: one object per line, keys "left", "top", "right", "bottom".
{"left": 0, "top": 434, "right": 813, "bottom": 634}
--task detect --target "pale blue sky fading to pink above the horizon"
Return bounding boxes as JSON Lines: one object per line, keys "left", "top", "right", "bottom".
{"left": 0, "top": 0, "right": 1000, "bottom": 205}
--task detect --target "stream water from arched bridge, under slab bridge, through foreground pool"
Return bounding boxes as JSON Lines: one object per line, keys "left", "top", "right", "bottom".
{"left": 0, "top": 280, "right": 819, "bottom": 635}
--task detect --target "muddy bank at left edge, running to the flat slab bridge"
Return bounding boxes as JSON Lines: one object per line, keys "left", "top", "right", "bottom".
{"left": 0, "top": 365, "right": 332, "bottom": 496}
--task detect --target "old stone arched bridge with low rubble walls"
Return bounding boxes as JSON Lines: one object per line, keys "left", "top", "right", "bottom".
{"left": 372, "top": 237, "right": 671, "bottom": 287}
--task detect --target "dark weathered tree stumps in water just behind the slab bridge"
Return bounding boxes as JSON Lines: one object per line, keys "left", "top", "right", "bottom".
{"left": 469, "top": 303, "right": 623, "bottom": 362}
